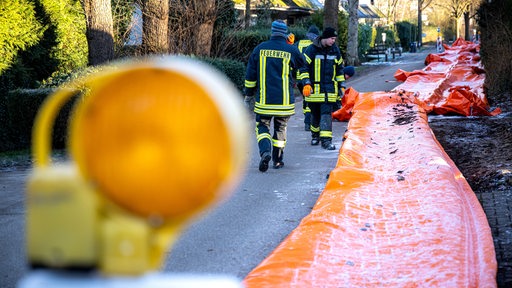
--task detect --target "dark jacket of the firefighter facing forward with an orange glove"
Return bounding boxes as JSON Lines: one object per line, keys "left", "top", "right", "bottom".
{"left": 298, "top": 38, "right": 345, "bottom": 102}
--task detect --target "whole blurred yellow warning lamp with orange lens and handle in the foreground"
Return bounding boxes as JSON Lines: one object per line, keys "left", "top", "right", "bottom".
{"left": 27, "top": 57, "right": 249, "bottom": 274}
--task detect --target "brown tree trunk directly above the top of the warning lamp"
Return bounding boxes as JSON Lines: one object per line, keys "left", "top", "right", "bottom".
{"left": 142, "top": 0, "right": 169, "bottom": 54}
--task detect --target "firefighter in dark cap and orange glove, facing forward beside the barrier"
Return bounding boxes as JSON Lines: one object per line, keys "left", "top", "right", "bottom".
{"left": 299, "top": 27, "right": 345, "bottom": 150}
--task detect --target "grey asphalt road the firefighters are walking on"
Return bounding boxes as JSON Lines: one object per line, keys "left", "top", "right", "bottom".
{"left": 0, "top": 49, "right": 434, "bottom": 288}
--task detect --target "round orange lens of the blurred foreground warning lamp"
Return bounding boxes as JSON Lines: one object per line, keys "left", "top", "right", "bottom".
{"left": 71, "top": 59, "right": 247, "bottom": 218}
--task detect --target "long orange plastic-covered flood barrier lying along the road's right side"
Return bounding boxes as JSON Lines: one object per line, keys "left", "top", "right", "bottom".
{"left": 244, "top": 41, "right": 497, "bottom": 288}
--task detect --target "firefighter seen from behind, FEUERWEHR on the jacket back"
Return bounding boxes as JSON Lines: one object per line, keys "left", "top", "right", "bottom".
{"left": 245, "top": 20, "right": 305, "bottom": 172}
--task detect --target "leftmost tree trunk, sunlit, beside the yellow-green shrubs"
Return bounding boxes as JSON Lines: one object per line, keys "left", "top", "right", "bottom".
{"left": 83, "top": 0, "right": 114, "bottom": 65}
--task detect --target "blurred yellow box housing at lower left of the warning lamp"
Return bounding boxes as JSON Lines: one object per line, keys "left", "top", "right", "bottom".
{"left": 26, "top": 165, "right": 99, "bottom": 268}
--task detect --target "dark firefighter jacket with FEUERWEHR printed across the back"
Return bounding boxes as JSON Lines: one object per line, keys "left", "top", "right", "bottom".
{"left": 245, "top": 36, "right": 305, "bottom": 116}
